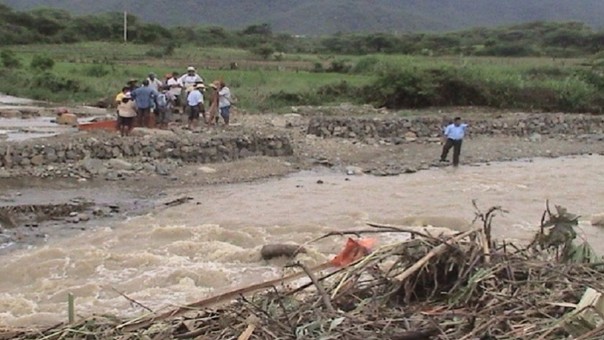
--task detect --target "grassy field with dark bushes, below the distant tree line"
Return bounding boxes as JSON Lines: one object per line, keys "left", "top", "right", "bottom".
{"left": 0, "top": 43, "right": 604, "bottom": 112}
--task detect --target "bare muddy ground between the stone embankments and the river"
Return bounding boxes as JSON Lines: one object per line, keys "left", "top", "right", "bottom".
{"left": 0, "top": 109, "right": 604, "bottom": 252}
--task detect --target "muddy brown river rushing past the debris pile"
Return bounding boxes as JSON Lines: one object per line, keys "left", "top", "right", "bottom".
{"left": 0, "top": 156, "right": 604, "bottom": 327}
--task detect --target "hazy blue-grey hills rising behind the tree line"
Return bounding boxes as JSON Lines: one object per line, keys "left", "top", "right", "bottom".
{"left": 0, "top": 0, "right": 604, "bottom": 35}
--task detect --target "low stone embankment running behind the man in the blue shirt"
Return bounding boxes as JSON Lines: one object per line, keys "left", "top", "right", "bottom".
{"left": 307, "top": 114, "right": 604, "bottom": 141}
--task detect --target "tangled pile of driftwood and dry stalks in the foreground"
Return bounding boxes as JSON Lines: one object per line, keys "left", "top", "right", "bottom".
{"left": 0, "top": 202, "right": 604, "bottom": 340}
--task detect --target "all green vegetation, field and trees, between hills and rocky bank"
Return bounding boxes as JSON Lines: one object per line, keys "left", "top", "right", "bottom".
{"left": 0, "top": 4, "right": 604, "bottom": 112}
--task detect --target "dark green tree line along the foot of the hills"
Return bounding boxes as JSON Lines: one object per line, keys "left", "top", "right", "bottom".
{"left": 0, "top": 4, "right": 604, "bottom": 59}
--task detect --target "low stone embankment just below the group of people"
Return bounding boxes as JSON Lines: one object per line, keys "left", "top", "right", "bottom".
{"left": 0, "top": 131, "right": 293, "bottom": 178}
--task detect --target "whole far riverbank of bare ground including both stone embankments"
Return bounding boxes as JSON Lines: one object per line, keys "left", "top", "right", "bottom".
{"left": 0, "top": 106, "right": 604, "bottom": 251}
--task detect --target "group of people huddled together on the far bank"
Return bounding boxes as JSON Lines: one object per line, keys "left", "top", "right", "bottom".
{"left": 115, "top": 66, "right": 234, "bottom": 136}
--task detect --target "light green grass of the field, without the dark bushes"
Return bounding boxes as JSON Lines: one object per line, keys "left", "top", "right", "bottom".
{"left": 0, "top": 42, "right": 594, "bottom": 112}
